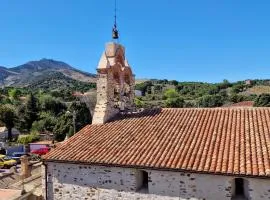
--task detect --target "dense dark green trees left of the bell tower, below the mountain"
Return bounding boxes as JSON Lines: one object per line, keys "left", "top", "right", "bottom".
{"left": 0, "top": 84, "right": 93, "bottom": 144}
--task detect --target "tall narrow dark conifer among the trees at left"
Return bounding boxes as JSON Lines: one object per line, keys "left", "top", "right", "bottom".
{"left": 24, "top": 93, "right": 38, "bottom": 130}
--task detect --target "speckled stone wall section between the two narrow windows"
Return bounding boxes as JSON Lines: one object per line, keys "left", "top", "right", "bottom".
{"left": 149, "top": 171, "right": 232, "bottom": 200}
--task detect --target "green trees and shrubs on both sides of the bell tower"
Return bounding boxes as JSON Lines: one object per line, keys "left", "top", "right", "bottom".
{"left": 0, "top": 77, "right": 270, "bottom": 144}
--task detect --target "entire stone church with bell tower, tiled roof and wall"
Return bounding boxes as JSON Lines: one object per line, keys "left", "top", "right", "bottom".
{"left": 43, "top": 43, "right": 270, "bottom": 200}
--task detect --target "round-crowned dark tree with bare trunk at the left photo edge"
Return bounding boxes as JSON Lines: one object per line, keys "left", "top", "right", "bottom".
{"left": 0, "top": 104, "right": 16, "bottom": 141}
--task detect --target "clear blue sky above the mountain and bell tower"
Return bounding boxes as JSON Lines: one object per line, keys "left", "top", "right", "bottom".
{"left": 0, "top": 0, "right": 270, "bottom": 82}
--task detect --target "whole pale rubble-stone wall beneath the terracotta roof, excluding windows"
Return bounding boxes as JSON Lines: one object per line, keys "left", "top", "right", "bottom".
{"left": 43, "top": 162, "right": 270, "bottom": 200}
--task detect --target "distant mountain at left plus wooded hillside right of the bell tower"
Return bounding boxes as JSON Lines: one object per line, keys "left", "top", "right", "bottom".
{"left": 0, "top": 59, "right": 270, "bottom": 107}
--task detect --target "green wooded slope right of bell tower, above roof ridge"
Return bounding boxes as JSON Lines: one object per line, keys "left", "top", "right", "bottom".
{"left": 135, "top": 79, "right": 270, "bottom": 108}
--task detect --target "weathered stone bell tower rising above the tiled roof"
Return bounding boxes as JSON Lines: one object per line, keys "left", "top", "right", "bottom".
{"left": 92, "top": 42, "right": 135, "bottom": 124}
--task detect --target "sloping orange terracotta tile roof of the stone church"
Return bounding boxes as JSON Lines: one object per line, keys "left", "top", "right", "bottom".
{"left": 44, "top": 108, "right": 270, "bottom": 177}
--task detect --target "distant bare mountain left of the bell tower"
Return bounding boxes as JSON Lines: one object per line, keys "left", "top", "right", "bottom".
{"left": 0, "top": 59, "right": 96, "bottom": 88}
